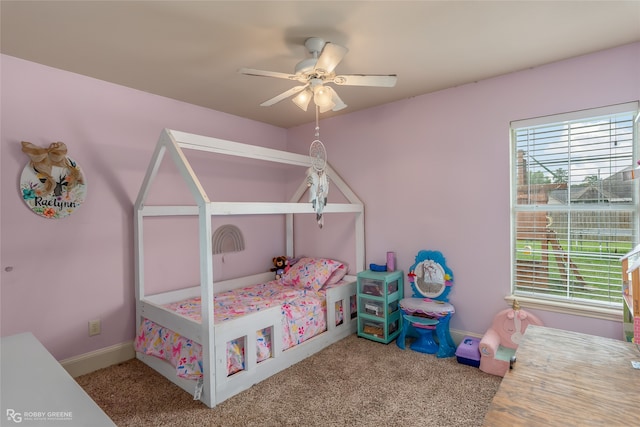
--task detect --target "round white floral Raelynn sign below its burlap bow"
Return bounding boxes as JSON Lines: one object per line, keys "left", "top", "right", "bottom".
{"left": 20, "top": 157, "right": 87, "bottom": 218}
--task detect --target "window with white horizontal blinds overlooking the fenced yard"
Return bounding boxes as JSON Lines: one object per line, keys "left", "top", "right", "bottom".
{"left": 511, "top": 102, "right": 640, "bottom": 314}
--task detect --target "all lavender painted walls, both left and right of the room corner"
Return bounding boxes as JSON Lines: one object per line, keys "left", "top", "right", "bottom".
{"left": 0, "top": 43, "right": 640, "bottom": 359}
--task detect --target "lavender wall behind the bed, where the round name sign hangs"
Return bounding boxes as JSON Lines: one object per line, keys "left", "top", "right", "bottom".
{"left": 0, "top": 55, "right": 286, "bottom": 359}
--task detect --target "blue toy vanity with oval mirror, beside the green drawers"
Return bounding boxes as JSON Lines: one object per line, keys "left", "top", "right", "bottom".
{"left": 396, "top": 250, "right": 456, "bottom": 357}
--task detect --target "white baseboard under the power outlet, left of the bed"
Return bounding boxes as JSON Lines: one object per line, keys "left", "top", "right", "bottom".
{"left": 60, "top": 341, "right": 136, "bottom": 378}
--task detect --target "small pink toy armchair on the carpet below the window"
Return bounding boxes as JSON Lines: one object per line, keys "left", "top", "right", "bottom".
{"left": 478, "top": 300, "right": 543, "bottom": 377}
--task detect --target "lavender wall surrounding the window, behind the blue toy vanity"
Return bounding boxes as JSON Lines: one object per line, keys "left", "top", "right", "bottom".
{"left": 288, "top": 43, "right": 640, "bottom": 338}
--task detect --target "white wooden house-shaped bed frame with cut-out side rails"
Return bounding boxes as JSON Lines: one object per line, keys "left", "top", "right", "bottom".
{"left": 134, "top": 129, "right": 365, "bottom": 407}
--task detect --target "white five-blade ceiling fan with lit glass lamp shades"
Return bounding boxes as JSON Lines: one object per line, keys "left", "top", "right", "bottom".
{"left": 238, "top": 37, "right": 398, "bottom": 113}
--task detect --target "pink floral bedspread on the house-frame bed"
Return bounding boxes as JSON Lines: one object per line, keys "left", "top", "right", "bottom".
{"left": 135, "top": 281, "right": 342, "bottom": 379}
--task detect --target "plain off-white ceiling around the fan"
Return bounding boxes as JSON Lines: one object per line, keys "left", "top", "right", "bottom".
{"left": 0, "top": 0, "right": 640, "bottom": 128}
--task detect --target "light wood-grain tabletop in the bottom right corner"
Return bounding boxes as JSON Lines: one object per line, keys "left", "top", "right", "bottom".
{"left": 484, "top": 326, "right": 640, "bottom": 427}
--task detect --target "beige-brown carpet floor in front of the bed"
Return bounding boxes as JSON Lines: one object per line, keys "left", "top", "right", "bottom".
{"left": 76, "top": 335, "right": 502, "bottom": 427}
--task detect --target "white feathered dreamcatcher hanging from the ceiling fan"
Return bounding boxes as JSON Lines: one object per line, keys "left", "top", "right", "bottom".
{"left": 307, "top": 106, "right": 329, "bottom": 228}
